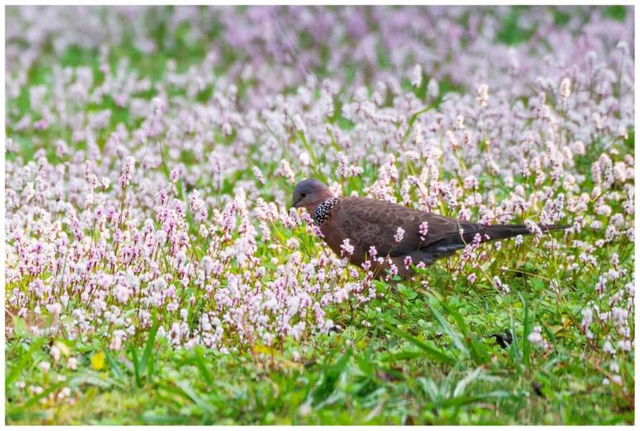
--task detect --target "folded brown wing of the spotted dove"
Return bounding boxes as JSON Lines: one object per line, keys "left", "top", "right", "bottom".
{"left": 334, "top": 197, "right": 460, "bottom": 257}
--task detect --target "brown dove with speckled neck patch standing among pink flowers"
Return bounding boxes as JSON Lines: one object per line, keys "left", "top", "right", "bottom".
{"left": 292, "top": 178, "right": 570, "bottom": 280}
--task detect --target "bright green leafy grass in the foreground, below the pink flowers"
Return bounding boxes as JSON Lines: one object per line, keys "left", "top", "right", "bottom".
{"left": 6, "top": 269, "right": 634, "bottom": 424}
